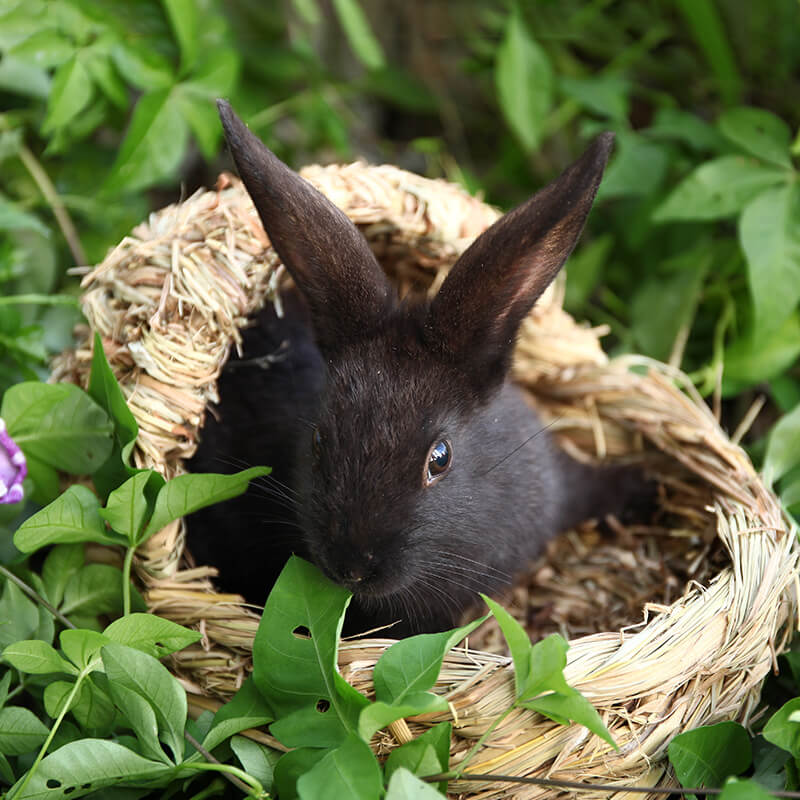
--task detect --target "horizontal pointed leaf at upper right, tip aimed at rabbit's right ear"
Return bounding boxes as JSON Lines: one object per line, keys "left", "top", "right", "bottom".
{"left": 653, "top": 156, "right": 788, "bottom": 222}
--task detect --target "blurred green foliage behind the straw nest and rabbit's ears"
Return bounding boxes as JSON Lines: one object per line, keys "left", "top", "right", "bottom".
{"left": 0, "top": 0, "right": 800, "bottom": 792}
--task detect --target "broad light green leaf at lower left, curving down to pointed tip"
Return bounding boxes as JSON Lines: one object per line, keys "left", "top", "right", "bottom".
{"left": 102, "top": 644, "right": 187, "bottom": 762}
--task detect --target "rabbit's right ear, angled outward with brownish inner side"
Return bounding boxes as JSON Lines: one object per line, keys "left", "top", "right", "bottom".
{"left": 425, "top": 133, "right": 614, "bottom": 382}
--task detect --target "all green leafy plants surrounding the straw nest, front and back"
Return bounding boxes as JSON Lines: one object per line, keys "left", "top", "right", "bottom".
{"left": 0, "top": 0, "right": 800, "bottom": 798}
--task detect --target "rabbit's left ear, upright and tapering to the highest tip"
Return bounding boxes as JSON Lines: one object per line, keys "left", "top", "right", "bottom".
{"left": 217, "top": 100, "right": 395, "bottom": 353}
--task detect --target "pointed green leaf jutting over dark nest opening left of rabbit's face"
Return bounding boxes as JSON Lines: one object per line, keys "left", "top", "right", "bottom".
{"left": 140, "top": 467, "right": 270, "bottom": 542}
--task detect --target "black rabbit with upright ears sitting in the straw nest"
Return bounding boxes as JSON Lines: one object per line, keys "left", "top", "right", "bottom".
{"left": 189, "top": 101, "right": 639, "bottom": 635}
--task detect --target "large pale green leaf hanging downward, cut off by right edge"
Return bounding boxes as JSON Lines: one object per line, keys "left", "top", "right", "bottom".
{"left": 739, "top": 183, "right": 800, "bottom": 335}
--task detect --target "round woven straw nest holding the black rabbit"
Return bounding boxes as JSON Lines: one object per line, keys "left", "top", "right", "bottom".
{"left": 55, "top": 159, "right": 798, "bottom": 798}
